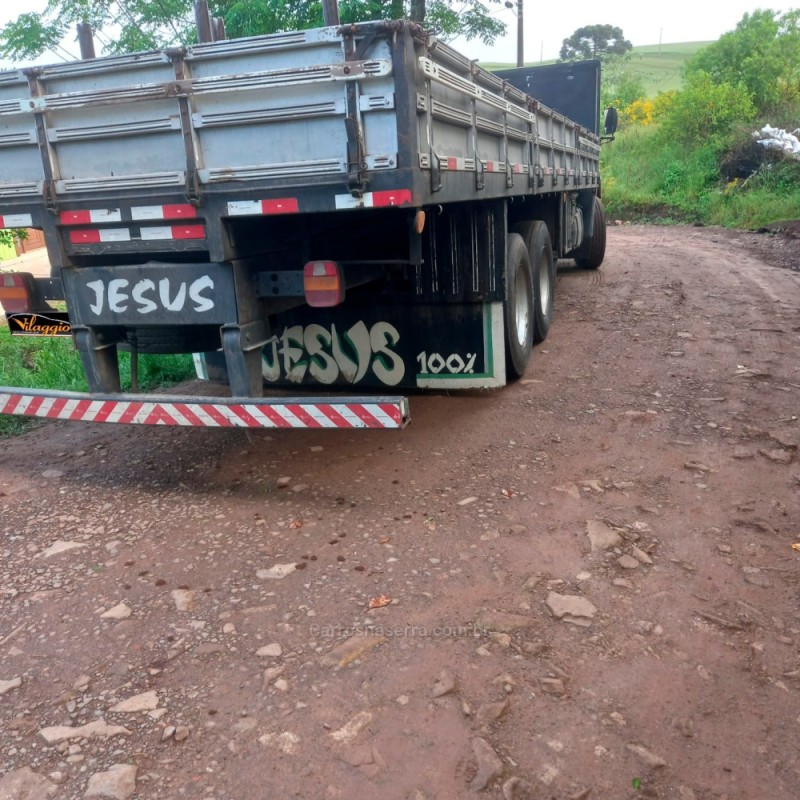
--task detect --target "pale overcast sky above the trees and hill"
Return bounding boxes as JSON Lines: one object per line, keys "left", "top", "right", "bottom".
{"left": 0, "top": 0, "right": 794, "bottom": 68}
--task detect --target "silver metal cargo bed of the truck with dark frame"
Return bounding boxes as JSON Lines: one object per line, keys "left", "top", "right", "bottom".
{"left": 0, "top": 22, "right": 599, "bottom": 267}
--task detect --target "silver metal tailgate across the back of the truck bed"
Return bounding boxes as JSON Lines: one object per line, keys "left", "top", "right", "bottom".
{"left": 0, "top": 28, "right": 400, "bottom": 204}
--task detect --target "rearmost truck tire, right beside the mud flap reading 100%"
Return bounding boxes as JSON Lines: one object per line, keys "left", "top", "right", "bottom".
{"left": 503, "top": 233, "right": 533, "bottom": 379}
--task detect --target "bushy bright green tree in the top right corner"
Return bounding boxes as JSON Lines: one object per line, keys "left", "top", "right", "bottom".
{"left": 685, "top": 10, "right": 800, "bottom": 113}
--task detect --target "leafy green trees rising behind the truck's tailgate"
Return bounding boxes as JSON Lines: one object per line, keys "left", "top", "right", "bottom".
{"left": 0, "top": 0, "right": 506, "bottom": 62}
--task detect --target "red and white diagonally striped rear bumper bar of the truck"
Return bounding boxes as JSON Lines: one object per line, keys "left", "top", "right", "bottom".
{"left": 0, "top": 389, "right": 409, "bottom": 430}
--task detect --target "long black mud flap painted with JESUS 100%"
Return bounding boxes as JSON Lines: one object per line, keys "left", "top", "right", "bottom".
{"left": 195, "top": 303, "right": 506, "bottom": 390}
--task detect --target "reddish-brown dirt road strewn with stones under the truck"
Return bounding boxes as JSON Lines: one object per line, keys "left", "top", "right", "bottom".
{"left": 0, "top": 226, "right": 800, "bottom": 800}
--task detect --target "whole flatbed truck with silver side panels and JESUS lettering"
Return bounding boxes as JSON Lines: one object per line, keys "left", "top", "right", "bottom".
{"left": 0, "top": 20, "right": 606, "bottom": 428}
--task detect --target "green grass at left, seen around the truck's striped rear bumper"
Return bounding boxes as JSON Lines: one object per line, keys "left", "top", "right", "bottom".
{"left": 0, "top": 325, "right": 195, "bottom": 437}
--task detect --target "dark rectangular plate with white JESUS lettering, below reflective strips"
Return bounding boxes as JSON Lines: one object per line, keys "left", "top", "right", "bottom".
{"left": 61, "top": 263, "right": 237, "bottom": 327}
